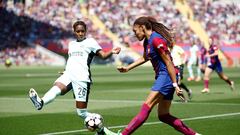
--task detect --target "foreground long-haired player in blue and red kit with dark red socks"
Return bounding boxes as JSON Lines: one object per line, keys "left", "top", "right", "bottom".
{"left": 106, "top": 17, "right": 201, "bottom": 135}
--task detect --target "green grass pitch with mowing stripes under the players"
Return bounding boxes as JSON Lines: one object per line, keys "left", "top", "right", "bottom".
{"left": 0, "top": 65, "right": 240, "bottom": 135}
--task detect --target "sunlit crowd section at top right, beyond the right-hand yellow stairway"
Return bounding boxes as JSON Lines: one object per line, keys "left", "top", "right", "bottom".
{"left": 189, "top": 0, "right": 240, "bottom": 44}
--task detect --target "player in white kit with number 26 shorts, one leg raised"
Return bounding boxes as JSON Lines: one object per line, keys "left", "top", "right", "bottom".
{"left": 29, "top": 21, "right": 121, "bottom": 134}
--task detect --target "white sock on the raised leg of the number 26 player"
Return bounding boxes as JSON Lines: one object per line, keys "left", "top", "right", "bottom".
{"left": 42, "top": 86, "right": 61, "bottom": 105}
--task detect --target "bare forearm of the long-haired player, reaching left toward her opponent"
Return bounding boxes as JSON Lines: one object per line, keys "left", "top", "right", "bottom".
{"left": 117, "top": 57, "right": 147, "bottom": 73}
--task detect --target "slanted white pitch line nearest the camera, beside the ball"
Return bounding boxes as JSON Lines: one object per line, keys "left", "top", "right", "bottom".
{"left": 40, "top": 112, "right": 240, "bottom": 135}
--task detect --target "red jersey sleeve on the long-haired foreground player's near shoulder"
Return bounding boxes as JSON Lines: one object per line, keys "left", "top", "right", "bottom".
{"left": 152, "top": 37, "right": 169, "bottom": 53}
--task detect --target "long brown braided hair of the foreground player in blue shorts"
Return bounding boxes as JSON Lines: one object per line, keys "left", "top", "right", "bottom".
{"left": 134, "top": 16, "right": 174, "bottom": 47}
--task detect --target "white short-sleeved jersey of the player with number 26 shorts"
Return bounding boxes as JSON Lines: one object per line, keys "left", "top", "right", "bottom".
{"left": 65, "top": 38, "right": 102, "bottom": 82}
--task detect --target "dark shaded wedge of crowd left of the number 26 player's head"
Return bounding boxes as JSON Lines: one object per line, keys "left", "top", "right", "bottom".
{"left": 0, "top": 4, "right": 69, "bottom": 49}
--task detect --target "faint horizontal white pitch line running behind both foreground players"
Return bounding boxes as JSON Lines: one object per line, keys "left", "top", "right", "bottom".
{"left": 0, "top": 97, "right": 240, "bottom": 106}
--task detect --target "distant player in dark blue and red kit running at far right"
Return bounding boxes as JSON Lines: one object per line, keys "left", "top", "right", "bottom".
{"left": 201, "top": 38, "right": 234, "bottom": 93}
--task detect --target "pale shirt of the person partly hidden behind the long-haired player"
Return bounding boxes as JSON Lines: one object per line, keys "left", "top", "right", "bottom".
{"left": 171, "top": 45, "right": 184, "bottom": 66}
